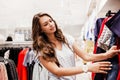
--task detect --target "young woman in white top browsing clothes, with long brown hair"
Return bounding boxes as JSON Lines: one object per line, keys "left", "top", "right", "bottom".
{"left": 32, "top": 13, "right": 120, "bottom": 80}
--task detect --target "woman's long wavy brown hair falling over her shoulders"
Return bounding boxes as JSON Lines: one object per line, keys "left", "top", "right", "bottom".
{"left": 32, "top": 13, "right": 69, "bottom": 65}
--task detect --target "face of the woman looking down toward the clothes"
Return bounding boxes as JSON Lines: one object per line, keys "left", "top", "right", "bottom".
{"left": 40, "top": 16, "right": 56, "bottom": 34}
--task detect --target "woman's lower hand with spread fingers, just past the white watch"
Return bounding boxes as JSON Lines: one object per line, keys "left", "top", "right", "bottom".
{"left": 88, "top": 61, "right": 112, "bottom": 74}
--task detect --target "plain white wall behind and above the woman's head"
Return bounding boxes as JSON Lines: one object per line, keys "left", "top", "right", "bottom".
{"left": 0, "top": 0, "right": 91, "bottom": 35}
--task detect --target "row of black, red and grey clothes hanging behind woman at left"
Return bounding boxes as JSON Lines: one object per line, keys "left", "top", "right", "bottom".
{"left": 0, "top": 46, "right": 48, "bottom": 80}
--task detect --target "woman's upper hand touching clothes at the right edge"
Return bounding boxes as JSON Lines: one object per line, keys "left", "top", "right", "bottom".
{"left": 105, "top": 46, "right": 120, "bottom": 58}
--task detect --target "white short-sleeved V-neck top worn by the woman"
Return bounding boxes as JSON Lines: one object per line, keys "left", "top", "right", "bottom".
{"left": 48, "top": 34, "right": 75, "bottom": 80}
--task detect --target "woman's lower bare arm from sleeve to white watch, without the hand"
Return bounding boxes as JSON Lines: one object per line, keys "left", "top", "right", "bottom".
{"left": 39, "top": 57, "right": 83, "bottom": 77}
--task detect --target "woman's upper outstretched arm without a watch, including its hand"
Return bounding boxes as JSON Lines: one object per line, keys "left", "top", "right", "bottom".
{"left": 73, "top": 42, "right": 120, "bottom": 61}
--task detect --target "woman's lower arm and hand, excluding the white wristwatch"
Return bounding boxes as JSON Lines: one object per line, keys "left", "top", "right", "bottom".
{"left": 39, "top": 56, "right": 111, "bottom": 77}
